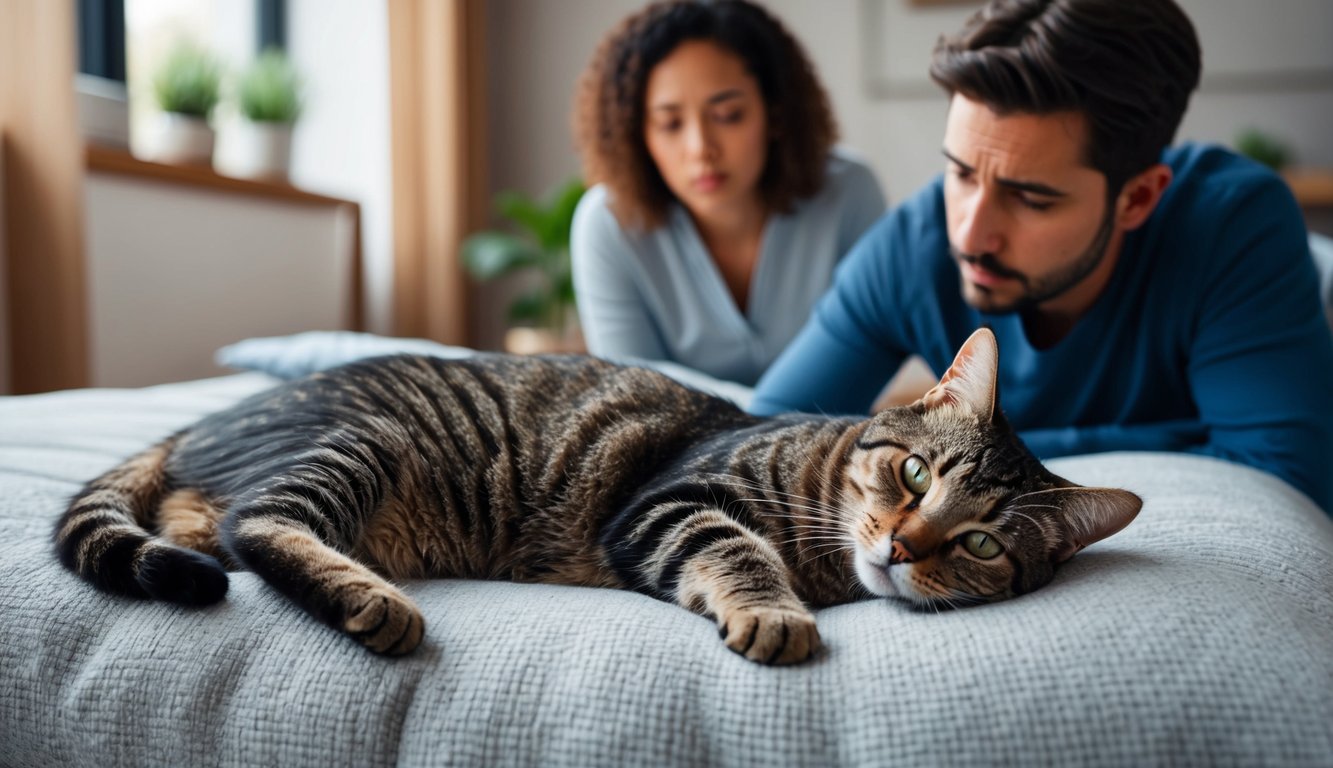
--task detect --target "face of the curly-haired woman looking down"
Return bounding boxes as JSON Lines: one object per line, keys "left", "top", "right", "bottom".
{"left": 644, "top": 40, "right": 768, "bottom": 219}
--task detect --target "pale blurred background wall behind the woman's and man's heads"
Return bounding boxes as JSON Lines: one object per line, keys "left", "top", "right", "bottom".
{"left": 488, "top": 0, "right": 1333, "bottom": 201}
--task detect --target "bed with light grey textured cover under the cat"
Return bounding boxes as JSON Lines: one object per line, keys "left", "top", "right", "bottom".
{"left": 0, "top": 338, "right": 1333, "bottom": 767}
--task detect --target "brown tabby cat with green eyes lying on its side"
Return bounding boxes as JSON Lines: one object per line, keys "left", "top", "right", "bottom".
{"left": 55, "top": 329, "right": 1140, "bottom": 664}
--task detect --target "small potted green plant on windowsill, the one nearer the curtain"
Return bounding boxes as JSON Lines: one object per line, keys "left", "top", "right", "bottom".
{"left": 235, "top": 49, "right": 301, "bottom": 181}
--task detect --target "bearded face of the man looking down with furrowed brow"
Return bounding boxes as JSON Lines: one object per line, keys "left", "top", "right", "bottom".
{"left": 944, "top": 96, "right": 1120, "bottom": 312}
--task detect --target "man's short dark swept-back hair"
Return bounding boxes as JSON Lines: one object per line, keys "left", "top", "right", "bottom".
{"left": 930, "top": 0, "right": 1201, "bottom": 195}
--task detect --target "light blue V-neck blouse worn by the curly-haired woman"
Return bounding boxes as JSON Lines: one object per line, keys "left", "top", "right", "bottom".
{"left": 571, "top": 151, "right": 885, "bottom": 385}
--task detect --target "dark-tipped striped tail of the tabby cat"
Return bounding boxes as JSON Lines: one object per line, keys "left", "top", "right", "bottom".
{"left": 55, "top": 437, "right": 227, "bottom": 605}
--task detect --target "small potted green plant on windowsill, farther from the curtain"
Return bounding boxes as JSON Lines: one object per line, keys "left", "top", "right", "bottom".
{"left": 151, "top": 43, "right": 223, "bottom": 165}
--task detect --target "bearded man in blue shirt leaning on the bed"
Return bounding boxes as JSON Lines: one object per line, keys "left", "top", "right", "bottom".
{"left": 752, "top": 0, "right": 1333, "bottom": 513}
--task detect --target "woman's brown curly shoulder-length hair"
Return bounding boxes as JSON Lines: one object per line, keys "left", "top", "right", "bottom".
{"left": 573, "top": 0, "right": 837, "bottom": 229}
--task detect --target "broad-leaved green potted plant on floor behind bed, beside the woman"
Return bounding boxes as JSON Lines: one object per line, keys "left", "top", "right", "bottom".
{"left": 463, "top": 179, "right": 584, "bottom": 353}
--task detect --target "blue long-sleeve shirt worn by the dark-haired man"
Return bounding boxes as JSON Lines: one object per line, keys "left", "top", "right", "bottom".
{"left": 750, "top": 145, "right": 1333, "bottom": 515}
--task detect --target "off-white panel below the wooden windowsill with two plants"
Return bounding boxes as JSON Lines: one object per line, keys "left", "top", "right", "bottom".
{"left": 84, "top": 173, "right": 352, "bottom": 387}
